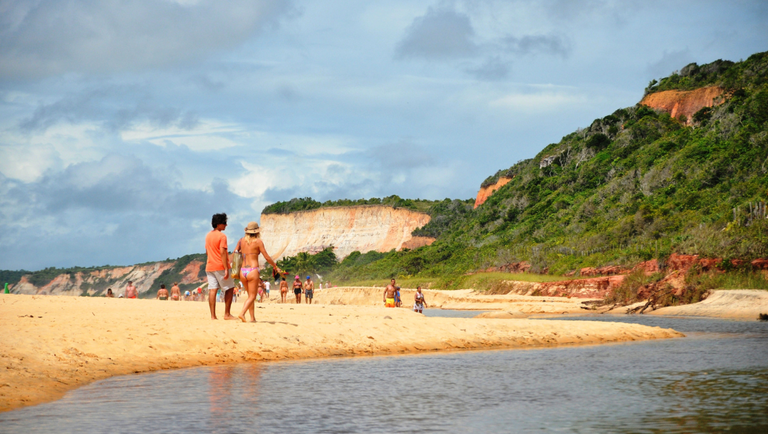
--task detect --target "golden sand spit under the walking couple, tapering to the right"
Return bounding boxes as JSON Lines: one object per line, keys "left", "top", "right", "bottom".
{"left": 0, "top": 292, "right": 683, "bottom": 411}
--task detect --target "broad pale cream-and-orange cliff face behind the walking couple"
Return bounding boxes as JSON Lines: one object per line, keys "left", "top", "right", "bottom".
{"left": 261, "top": 205, "right": 435, "bottom": 259}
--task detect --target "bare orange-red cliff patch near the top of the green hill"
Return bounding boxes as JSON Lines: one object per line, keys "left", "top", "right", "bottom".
{"left": 640, "top": 86, "right": 725, "bottom": 125}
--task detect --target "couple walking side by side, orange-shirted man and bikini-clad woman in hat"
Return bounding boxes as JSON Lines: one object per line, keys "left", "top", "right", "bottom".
{"left": 205, "top": 213, "right": 282, "bottom": 322}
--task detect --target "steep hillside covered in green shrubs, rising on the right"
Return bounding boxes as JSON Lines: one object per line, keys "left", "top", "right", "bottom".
{"left": 330, "top": 53, "right": 768, "bottom": 281}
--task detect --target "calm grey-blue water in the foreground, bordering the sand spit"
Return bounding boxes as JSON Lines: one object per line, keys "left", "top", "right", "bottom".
{"left": 0, "top": 316, "right": 768, "bottom": 433}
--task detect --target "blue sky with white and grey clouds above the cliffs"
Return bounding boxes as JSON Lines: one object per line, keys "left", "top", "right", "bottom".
{"left": 0, "top": 0, "right": 768, "bottom": 270}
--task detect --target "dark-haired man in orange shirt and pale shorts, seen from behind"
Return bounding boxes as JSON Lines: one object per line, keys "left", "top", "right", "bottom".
{"left": 205, "top": 213, "right": 237, "bottom": 320}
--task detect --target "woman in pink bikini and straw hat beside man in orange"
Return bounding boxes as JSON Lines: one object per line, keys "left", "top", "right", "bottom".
{"left": 235, "top": 222, "right": 282, "bottom": 322}
